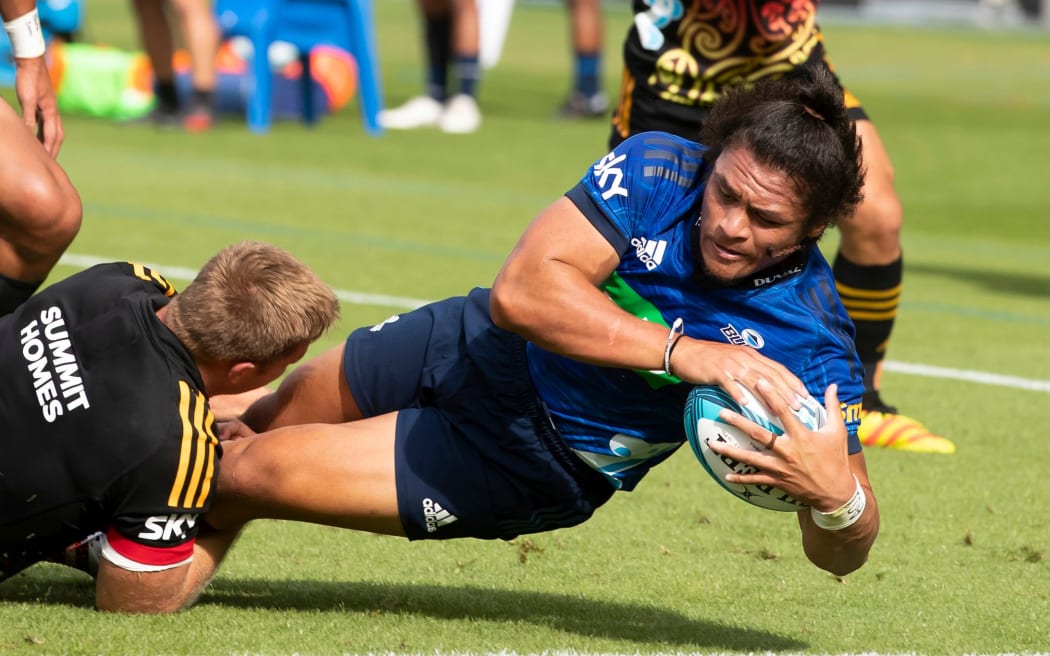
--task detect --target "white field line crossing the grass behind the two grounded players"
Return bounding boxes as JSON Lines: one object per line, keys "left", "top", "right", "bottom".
{"left": 59, "top": 253, "right": 1050, "bottom": 393}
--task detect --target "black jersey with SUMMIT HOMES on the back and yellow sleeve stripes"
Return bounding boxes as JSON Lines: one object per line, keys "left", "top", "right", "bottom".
{"left": 0, "top": 262, "right": 221, "bottom": 566}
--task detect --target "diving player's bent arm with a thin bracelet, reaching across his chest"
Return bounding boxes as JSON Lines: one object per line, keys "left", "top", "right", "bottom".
{"left": 490, "top": 197, "right": 804, "bottom": 398}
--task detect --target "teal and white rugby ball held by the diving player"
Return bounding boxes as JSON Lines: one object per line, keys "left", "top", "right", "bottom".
{"left": 685, "top": 385, "right": 827, "bottom": 512}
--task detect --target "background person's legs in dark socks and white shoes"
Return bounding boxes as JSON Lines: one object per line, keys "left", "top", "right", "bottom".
{"left": 379, "top": 0, "right": 481, "bottom": 134}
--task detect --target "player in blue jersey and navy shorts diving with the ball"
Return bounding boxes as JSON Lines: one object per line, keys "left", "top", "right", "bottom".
{"left": 208, "top": 68, "right": 879, "bottom": 575}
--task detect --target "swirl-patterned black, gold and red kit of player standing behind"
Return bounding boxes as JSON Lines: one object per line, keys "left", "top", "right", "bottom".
{"left": 610, "top": 0, "right": 866, "bottom": 146}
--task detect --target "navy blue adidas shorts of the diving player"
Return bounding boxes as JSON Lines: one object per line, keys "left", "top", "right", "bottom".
{"left": 343, "top": 289, "right": 613, "bottom": 539}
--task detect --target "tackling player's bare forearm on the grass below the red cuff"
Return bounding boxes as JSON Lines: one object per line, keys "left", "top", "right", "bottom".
{"left": 96, "top": 518, "right": 237, "bottom": 613}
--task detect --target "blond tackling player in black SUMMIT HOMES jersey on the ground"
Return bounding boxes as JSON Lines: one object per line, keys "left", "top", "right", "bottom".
{"left": 0, "top": 242, "right": 338, "bottom": 612}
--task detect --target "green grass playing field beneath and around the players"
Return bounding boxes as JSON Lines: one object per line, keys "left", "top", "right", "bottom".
{"left": 0, "top": 0, "right": 1050, "bottom": 655}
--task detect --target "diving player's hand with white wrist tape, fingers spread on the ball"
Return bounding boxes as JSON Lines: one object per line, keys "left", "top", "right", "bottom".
{"left": 711, "top": 383, "right": 879, "bottom": 576}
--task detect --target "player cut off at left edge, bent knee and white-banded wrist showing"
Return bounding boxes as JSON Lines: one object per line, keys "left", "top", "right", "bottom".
{"left": 0, "top": 0, "right": 83, "bottom": 315}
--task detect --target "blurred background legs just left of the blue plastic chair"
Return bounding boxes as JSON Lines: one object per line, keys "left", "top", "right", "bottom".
{"left": 131, "top": 0, "right": 222, "bottom": 132}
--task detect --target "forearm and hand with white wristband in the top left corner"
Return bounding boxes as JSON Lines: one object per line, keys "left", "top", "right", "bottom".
{"left": 0, "top": 0, "right": 64, "bottom": 157}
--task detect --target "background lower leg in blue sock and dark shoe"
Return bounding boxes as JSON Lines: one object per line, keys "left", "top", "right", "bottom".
{"left": 558, "top": 0, "right": 609, "bottom": 119}
